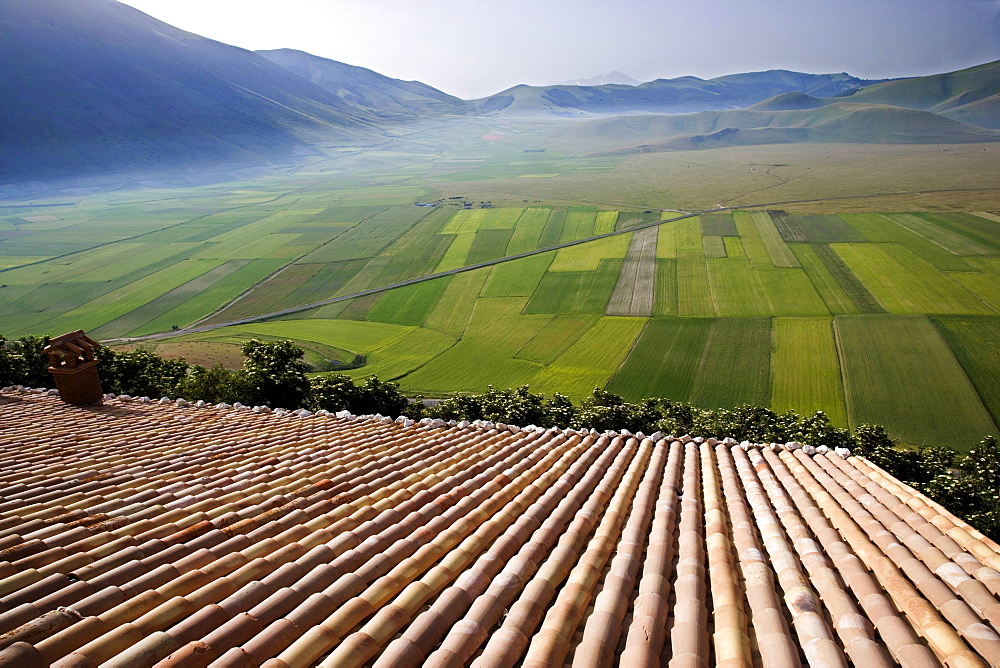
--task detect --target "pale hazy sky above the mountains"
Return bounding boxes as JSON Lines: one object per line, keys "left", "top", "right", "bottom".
{"left": 113, "top": 0, "right": 1000, "bottom": 99}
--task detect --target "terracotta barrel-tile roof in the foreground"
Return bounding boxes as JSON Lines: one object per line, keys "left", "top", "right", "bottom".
{"left": 0, "top": 389, "right": 1000, "bottom": 668}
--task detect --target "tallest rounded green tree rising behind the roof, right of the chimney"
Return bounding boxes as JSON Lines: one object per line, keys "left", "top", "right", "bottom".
{"left": 243, "top": 339, "right": 309, "bottom": 408}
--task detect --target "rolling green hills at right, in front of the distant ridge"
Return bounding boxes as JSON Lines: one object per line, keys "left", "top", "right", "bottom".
{"left": 556, "top": 61, "right": 1000, "bottom": 154}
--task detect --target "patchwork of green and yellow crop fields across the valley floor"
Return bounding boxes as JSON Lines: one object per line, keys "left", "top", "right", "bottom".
{"left": 0, "top": 181, "right": 1000, "bottom": 447}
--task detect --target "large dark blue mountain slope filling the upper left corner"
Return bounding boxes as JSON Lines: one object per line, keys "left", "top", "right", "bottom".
{"left": 0, "top": 0, "right": 382, "bottom": 183}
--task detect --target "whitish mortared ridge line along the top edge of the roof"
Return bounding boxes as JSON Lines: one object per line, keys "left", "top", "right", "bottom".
{"left": 0, "top": 385, "right": 851, "bottom": 458}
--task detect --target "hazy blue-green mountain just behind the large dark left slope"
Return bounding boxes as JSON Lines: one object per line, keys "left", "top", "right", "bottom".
{"left": 256, "top": 49, "right": 476, "bottom": 119}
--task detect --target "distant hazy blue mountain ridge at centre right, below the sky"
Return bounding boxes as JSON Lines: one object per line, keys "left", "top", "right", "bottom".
{"left": 475, "top": 70, "right": 888, "bottom": 118}
